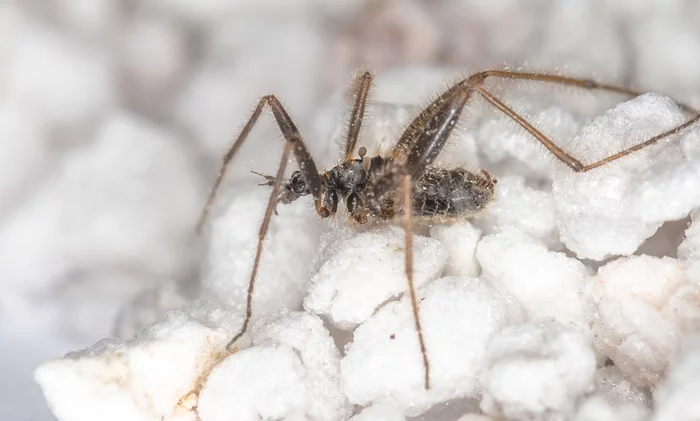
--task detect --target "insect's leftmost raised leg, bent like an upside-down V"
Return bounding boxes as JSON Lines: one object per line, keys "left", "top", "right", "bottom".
{"left": 197, "top": 95, "right": 327, "bottom": 232}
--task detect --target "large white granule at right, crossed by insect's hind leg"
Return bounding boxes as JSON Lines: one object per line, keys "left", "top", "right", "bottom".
{"left": 553, "top": 94, "right": 700, "bottom": 260}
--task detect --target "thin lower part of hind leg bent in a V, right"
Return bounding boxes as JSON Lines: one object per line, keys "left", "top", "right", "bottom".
{"left": 474, "top": 86, "right": 700, "bottom": 172}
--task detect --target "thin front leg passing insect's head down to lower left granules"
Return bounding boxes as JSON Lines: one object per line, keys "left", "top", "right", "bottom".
{"left": 226, "top": 139, "right": 292, "bottom": 352}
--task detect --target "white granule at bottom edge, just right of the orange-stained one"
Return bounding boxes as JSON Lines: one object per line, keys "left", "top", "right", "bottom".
{"left": 198, "top": 312, "right": 352, "bottom": 421}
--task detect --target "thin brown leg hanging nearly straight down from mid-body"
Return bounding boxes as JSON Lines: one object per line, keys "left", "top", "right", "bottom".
{"left": 403, "top": 175, "right": 430, "bottom": 390}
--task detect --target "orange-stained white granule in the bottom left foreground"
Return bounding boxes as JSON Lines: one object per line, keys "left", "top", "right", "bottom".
{"left": 35, "top": 303, "right": 241, "bottom": 421}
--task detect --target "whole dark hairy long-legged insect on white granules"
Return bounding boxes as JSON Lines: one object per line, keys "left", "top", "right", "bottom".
{"left": 197, "top": 70, "right": 700, "bottom": 389}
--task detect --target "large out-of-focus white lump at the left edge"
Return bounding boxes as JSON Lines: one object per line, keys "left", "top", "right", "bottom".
{"left": 0, "top": 112, "right": 203, "bottom": 337}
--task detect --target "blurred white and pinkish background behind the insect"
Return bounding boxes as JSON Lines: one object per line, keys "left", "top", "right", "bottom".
{"left": 0, "top": 0, "right": 700, "bottom": 421}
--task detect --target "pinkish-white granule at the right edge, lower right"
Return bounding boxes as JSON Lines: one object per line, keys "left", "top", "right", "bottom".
{"left": 589, "top": 256, "right": 700, "bottom": 387}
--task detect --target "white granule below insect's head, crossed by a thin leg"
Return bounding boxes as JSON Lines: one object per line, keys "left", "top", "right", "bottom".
{"left": 202, "top": 186, "right": 320, "bottom": 318}
